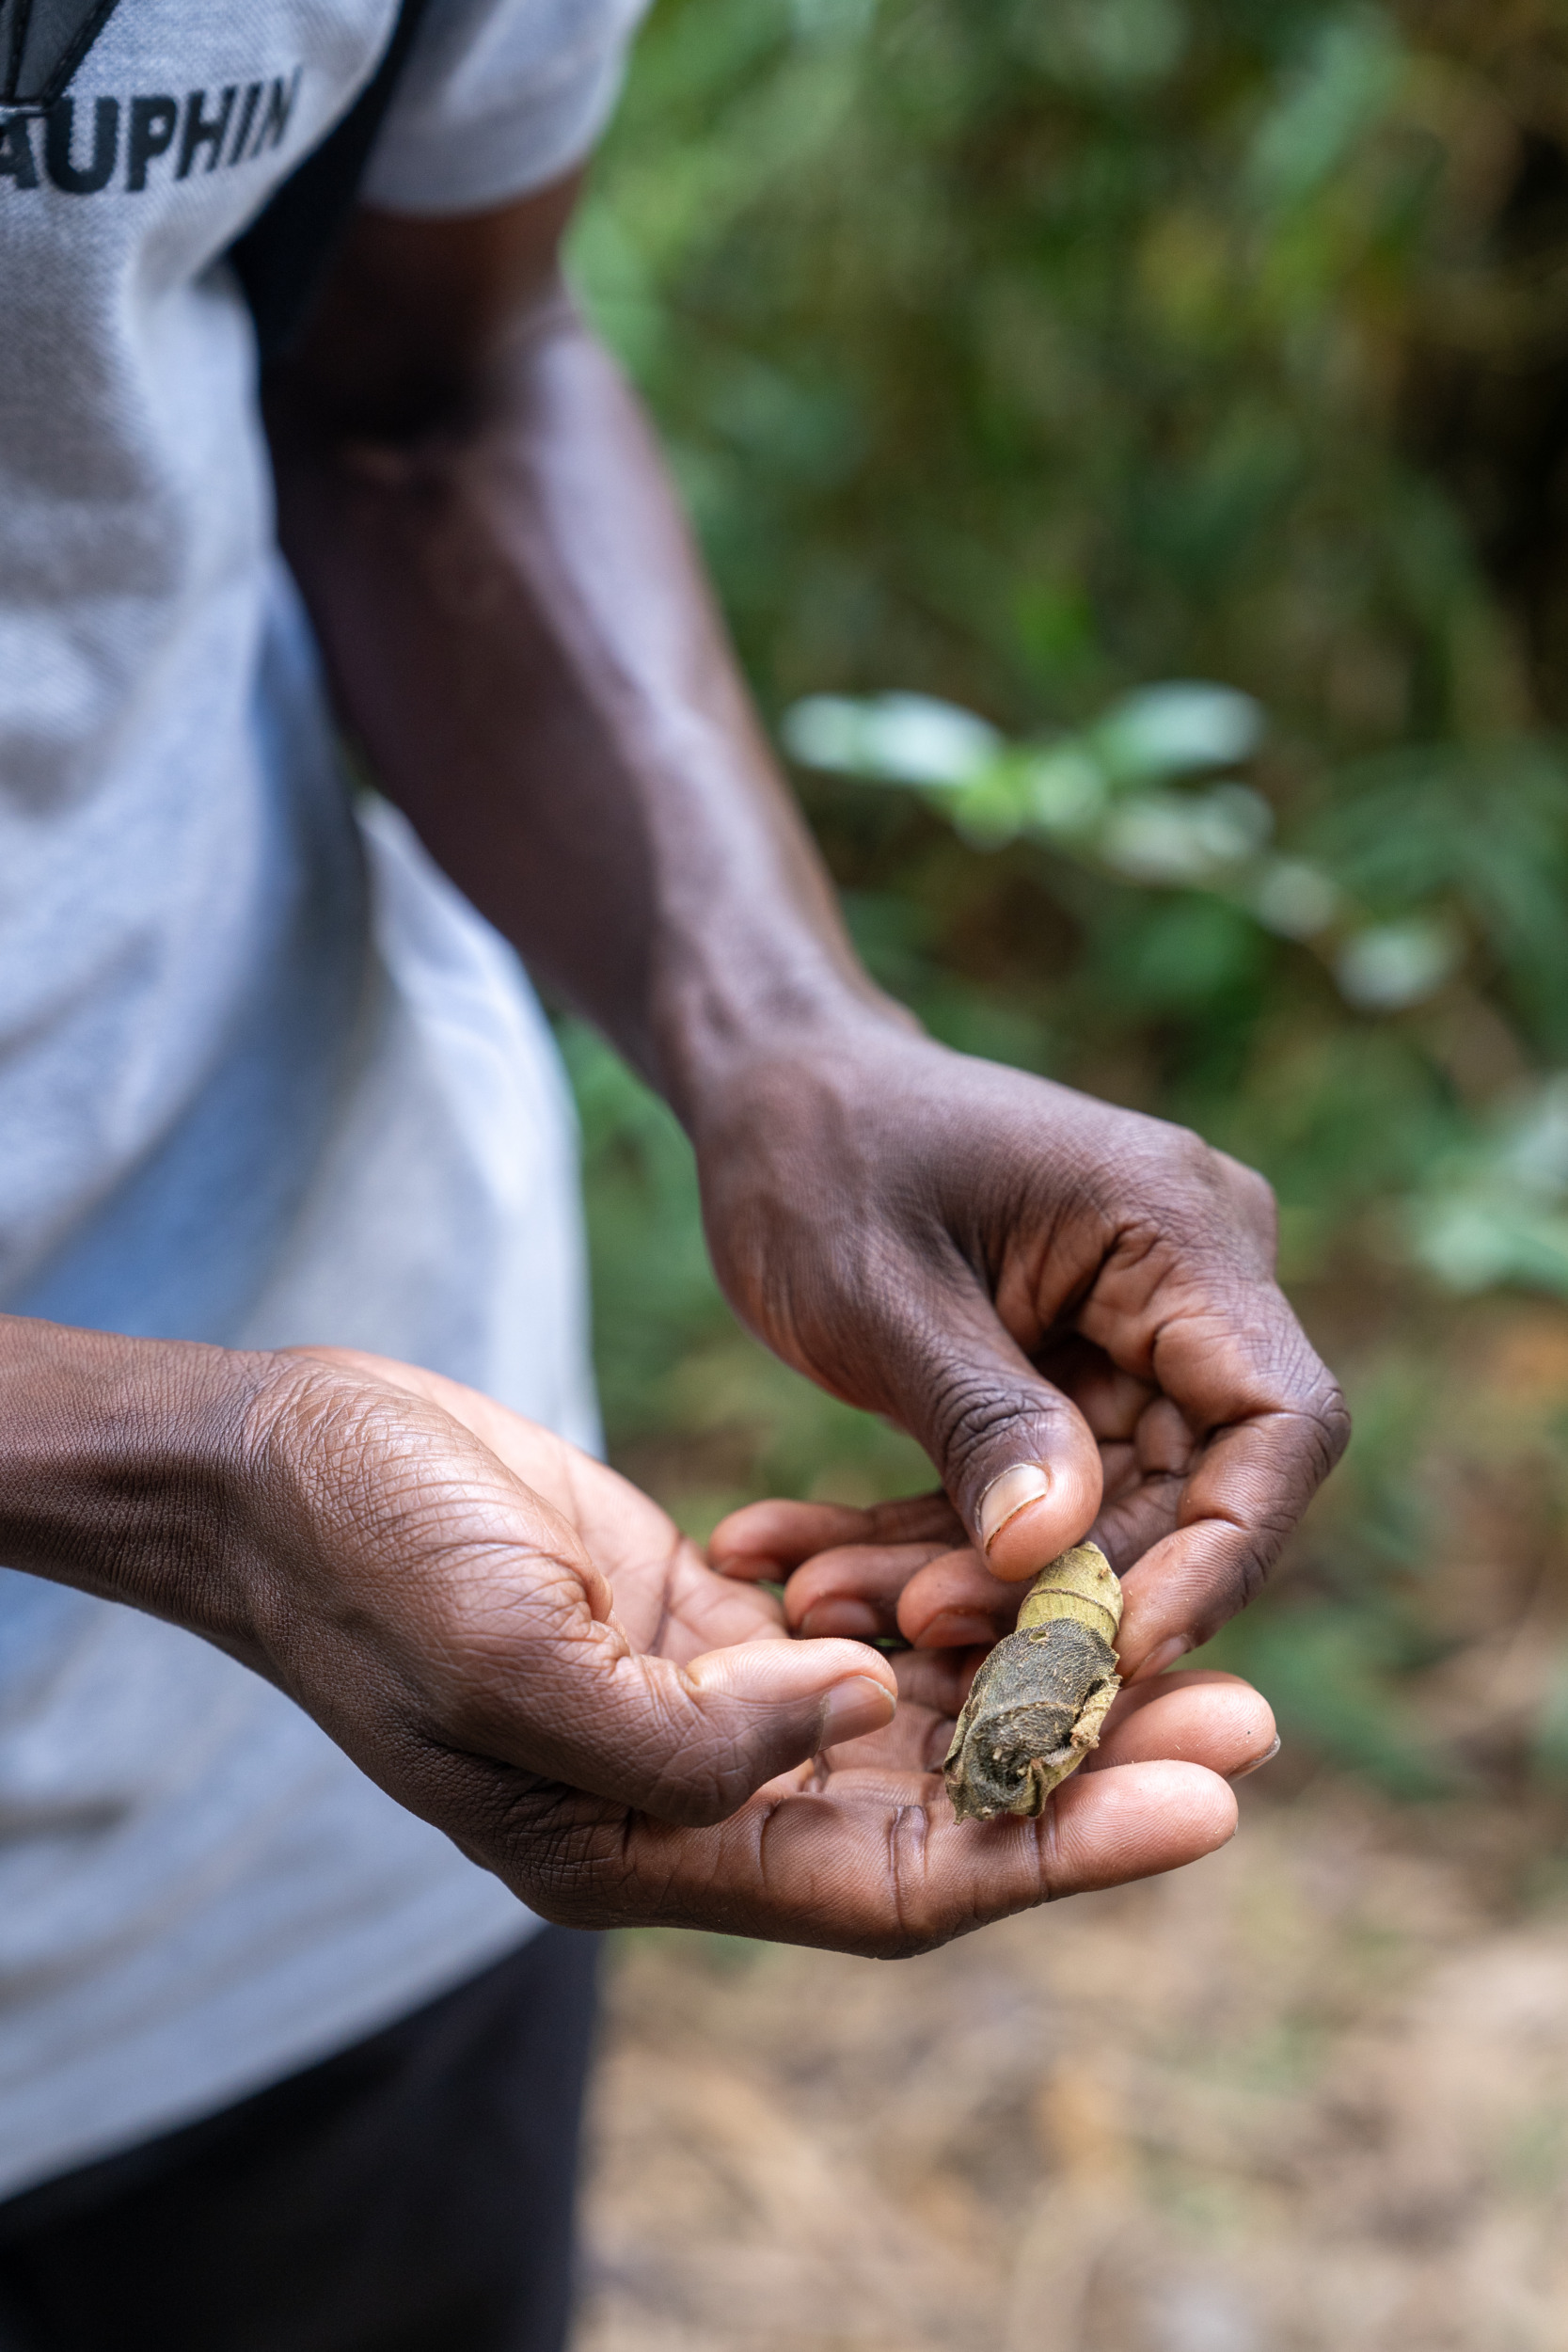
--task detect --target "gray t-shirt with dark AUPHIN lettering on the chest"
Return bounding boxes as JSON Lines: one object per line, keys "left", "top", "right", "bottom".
{"left": 0, "top": 0, "right": 640, "bottom": 2195}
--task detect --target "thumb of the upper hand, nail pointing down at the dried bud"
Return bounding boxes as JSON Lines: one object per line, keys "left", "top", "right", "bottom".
{"left": 894, "top": 1301, "right": 1102, "bottom": 1583}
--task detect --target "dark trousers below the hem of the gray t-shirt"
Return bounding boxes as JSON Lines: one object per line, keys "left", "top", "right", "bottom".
{"left": 0, "top": 1929, "right": 597, "bottom": 2352}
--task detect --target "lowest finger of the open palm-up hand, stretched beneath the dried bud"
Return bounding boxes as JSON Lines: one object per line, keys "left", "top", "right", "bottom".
{"left": 517, "top": 1764, "right": 1237, "bottom": 1960}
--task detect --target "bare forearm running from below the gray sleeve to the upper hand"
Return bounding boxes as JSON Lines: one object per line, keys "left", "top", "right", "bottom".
{"left": 262, "top": 243, "right": 891, "bottom": 1118}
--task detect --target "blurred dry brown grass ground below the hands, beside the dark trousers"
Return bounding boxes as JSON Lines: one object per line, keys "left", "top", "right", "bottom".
{"left": 576, "top": 1783, "right": 1568, "bottom": 2352}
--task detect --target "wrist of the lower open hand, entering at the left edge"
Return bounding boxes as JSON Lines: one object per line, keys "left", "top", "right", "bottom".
{"left": 0, "top": 1317, "right": 277, "bottom": 1654}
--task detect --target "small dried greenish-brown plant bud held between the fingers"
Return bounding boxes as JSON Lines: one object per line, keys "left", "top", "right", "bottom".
{"left": 942, "top": 1543, "right": 1121, "bottom": 1820}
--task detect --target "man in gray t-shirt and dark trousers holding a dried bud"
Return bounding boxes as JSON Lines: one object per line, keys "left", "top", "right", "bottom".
{"left": 0, "top": 0, "right": 1342, "bottom": 2352}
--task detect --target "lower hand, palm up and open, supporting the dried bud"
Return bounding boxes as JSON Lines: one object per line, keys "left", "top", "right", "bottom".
{"left": 230, "top": 1353, "right": 1272, "bottom": 1955}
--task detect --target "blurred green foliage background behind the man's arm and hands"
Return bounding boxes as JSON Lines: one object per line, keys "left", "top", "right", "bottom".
{"left": 569, "top": 0, "right": 1568, "bottom": 1792}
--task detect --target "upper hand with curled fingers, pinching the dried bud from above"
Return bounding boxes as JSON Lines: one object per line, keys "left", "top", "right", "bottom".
{"left": 696, "top": 1016, "right": 1350, "bottom": 1673}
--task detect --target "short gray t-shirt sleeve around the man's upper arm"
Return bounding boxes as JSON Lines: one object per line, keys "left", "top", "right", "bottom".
{"left": 359, "top": 0, "right": 649, "bottom": 215}
